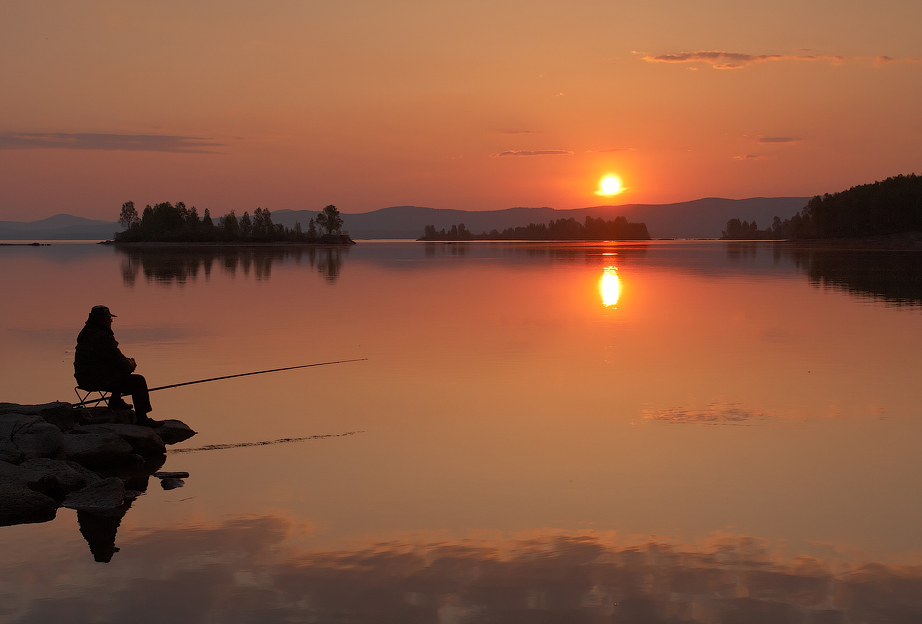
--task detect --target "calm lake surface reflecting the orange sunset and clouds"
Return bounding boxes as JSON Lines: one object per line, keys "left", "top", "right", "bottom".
{"left": 0, "top": 241, "right": 922, "bottom": 624}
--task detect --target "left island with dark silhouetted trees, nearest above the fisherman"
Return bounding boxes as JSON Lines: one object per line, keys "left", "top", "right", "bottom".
{"left": 115, "top": 201, "right": 352, "bottom": 244}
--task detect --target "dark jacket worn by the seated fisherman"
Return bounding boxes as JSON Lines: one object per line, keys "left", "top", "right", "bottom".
{"left": 74, "top": 318, "right": 134, "bottom": 390}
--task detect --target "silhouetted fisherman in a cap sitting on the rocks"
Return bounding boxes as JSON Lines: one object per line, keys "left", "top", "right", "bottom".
{"left": 74, "top": 306, "right": 163, "bottom": 427}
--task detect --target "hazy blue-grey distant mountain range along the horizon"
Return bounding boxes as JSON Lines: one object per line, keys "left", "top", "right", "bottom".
{"left": 0, "top": 197, "right": 810, "bottom": 240}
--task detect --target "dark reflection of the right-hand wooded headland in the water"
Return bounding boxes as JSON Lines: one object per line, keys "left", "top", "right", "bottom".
{"left": 785, "top": 247, "right": 922, "bottom": 306}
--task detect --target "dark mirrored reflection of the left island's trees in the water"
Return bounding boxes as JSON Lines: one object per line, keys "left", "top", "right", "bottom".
{"left": 118, "top": 245, "right": 348, "bottom": 286}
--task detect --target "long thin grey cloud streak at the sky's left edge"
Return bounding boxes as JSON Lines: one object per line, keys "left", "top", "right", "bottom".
{"left": 0, "top": 132, "right": 224, "bottom": 154}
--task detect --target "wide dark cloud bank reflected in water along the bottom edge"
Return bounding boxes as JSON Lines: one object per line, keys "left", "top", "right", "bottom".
{"left": 3, "top": 516, "right": 922, "bottom": 623}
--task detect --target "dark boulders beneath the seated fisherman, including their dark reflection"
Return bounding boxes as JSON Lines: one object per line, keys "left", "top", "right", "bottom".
{"left": 0, "top": 402, "right": 195, "bottom": 528}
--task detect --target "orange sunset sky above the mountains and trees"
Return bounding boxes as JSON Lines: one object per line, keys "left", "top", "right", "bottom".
{"left": 0, "top": 0, "right": 922, "bottom": 221}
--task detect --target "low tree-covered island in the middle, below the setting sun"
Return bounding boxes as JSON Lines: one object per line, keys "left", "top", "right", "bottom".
{"left": 418, "top": 216, "right": 650, "bottom": 241}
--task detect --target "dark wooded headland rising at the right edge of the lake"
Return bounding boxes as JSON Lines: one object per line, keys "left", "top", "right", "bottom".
{"left": 721, "top": 173, "right": 922, "bottom": 240}
